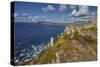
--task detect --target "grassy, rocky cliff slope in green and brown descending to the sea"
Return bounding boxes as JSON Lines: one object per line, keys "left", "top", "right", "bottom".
{"left": 19, "top": 20, "right": 97, "bottom": 65}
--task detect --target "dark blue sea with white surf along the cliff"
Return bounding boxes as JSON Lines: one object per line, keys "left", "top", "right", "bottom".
{"left": 14, "top": 22, "right": 64, "bottom": 63}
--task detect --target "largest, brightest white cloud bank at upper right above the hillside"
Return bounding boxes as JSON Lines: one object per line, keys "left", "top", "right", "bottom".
{"left": 69, "top": 6, "right": 96, "bottom": 21}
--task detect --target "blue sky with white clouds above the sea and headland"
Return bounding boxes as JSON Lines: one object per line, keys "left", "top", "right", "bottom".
{"left": 13, "top": 2, "right": 97, "bottom": 23}
